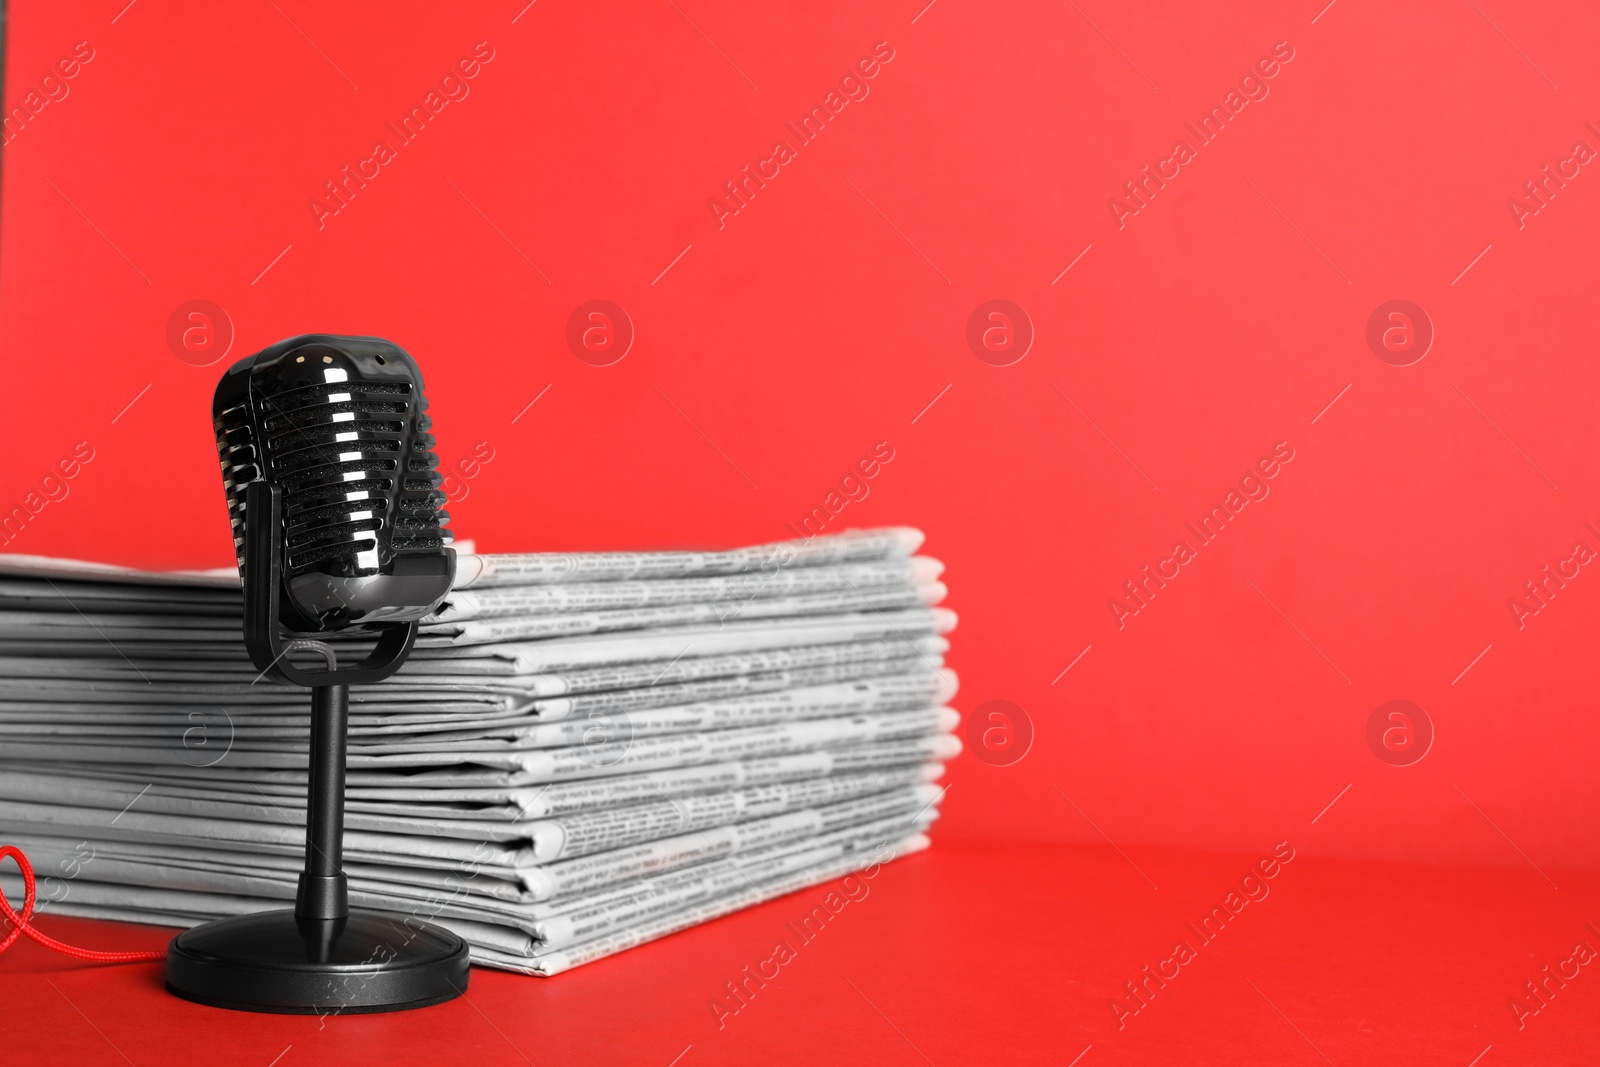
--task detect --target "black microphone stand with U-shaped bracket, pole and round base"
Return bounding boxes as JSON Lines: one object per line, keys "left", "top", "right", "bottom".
{"left": 166, "top": 482, "right": 470, "bottom": 1014}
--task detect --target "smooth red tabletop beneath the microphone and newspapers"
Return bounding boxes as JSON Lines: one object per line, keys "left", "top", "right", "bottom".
{"left": 0, "top": 845, "right": 1600, "bottom": 1067}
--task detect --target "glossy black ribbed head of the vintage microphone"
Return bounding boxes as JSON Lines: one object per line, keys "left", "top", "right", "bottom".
{"left": 211, "top": 334, "right": 456, "bottom": 633}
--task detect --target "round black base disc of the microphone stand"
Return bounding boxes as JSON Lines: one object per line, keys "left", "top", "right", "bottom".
{"left": 166, "top": 909, "right": 469, "bottom": 1016}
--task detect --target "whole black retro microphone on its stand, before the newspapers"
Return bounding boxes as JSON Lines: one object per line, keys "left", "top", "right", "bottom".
{"left": 166, "top": 334, "right": 469, "bottom": 1014}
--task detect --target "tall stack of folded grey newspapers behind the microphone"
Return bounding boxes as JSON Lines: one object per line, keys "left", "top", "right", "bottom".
{"left": 0, "top": 528, "right": 960, "bottom": 974}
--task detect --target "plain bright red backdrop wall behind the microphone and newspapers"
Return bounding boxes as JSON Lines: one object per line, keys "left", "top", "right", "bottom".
{"left": 0, "top": 0, "right": 1600, "bottom": 1062}
